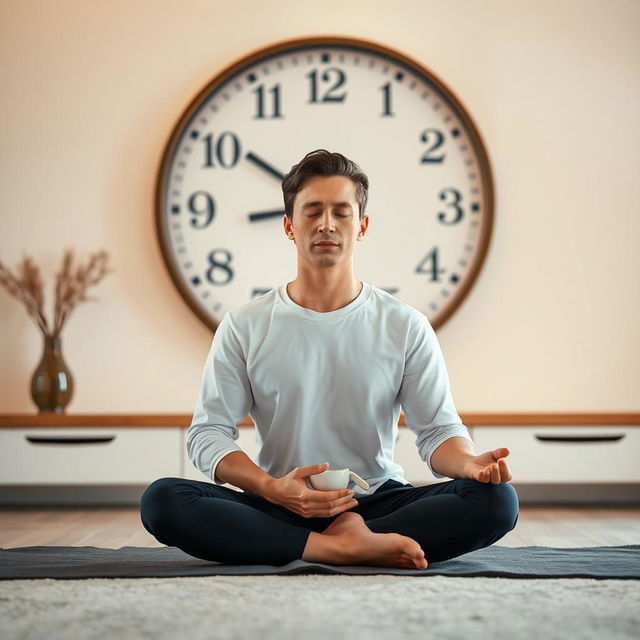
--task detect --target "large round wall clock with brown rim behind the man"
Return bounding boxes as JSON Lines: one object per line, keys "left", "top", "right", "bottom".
{"left": 156, "top": 36, "right": 494, "bottom": 331}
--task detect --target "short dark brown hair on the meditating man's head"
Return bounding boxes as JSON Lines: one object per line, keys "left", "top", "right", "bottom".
{"left": 282, "top": 149, "right": 369, "bottom": 220}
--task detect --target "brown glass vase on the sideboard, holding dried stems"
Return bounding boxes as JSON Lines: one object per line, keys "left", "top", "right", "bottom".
{"left": 31, "top": 336, "right": 73, "bottom": 413}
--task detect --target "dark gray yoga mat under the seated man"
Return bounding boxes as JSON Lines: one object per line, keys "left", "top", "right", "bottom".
{"left": 0, "top": 544, "right": 640, "bottom": 580}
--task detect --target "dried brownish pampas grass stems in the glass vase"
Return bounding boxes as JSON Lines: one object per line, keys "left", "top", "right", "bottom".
{"left": 0, "top": 249, "right": 113, "bottom": 338}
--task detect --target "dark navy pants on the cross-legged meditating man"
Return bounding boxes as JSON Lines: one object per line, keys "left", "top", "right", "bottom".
{"left": 140, "top": 478, "right": 519, "bottom": 566}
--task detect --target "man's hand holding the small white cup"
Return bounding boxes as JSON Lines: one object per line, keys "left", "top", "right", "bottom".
{"left": 263, "top": 463, "right": 358, "bottom": 518}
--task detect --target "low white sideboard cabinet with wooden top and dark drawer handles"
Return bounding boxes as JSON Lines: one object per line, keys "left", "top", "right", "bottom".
{"left": 0, "top": 414, "right": 640, "bottom": 505}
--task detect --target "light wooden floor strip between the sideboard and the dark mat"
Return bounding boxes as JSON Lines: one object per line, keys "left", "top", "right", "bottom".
{"left": 0, "top": 506, "right": 640, "bottom": 549}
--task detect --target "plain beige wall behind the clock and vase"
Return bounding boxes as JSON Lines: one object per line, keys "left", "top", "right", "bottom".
{"left": 0, "top": 0, "right": 640, "bottom": 413}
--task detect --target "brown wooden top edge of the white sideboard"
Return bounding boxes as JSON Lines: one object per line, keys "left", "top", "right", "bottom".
{"left": 0, "top": 413, "right": 640, "bottom": 427}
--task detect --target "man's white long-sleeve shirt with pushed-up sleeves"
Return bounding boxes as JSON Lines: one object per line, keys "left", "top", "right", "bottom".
{"left": 186, "top": 282, "right": 471, "bottom": 495}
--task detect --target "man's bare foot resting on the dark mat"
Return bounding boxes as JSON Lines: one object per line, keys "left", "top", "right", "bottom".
{"left": 302, "top": 512, "right": 428, "bottom": 569}
